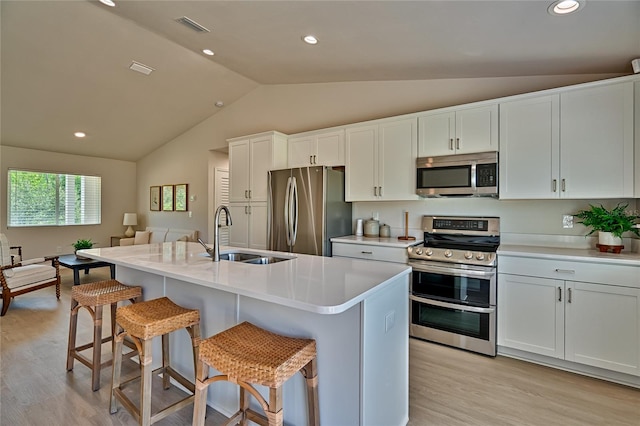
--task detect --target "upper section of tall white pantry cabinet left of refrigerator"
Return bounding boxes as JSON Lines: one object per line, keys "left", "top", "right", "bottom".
{"left": 229, "top": 132, "right": 287, "bottom": 203}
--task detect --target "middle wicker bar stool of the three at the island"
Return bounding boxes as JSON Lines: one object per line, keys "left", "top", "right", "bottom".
{"left": 109, "top": 297, "right": 200, "bottom": 426}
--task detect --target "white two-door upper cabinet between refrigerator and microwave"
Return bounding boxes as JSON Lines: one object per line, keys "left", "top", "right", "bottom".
{"left": 345, "top": 118, "right": 418, "bottom": 201}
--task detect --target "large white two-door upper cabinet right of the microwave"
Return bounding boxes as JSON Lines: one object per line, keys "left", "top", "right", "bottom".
{"left": 500, "top": 82, "right": 634, "bottom": 199}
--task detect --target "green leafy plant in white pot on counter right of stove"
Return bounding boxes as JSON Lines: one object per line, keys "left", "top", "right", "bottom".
{"left": 573, "top": 203, "right": 640, "bottom": 246}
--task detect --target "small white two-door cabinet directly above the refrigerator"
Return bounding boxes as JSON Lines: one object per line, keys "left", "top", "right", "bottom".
{"left": 288, "top": 129, "right": 344, "bottom": 167}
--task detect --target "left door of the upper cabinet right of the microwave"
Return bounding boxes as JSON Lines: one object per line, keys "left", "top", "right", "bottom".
{"left": 500, "top": 94, "right": 560, "bottom": 199}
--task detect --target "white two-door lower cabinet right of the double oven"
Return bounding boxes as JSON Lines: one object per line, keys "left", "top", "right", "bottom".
{"left": 497, "top": 258, "right": 640, "bottom": 376}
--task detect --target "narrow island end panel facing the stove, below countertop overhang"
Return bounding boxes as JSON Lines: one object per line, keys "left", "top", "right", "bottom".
{"left": 362, "top": 274, "right": 409, "bottom": 426}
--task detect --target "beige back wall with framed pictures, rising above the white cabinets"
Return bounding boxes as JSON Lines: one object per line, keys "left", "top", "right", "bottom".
{"left": 138, "top": 75, "right": 617, "bottom": 240}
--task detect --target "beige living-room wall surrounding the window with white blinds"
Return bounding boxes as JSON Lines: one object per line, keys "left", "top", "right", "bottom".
{"left": 0, "top": 146, "right": 140, "bottom": 258}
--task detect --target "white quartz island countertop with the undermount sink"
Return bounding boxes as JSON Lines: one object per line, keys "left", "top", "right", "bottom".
{"left": 81, "top": 242, "right": 411, "bottom": 314}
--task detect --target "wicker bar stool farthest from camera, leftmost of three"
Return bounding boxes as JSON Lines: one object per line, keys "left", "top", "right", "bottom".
{"left": 67, "top": 280, "right": 142, "bottom": 391}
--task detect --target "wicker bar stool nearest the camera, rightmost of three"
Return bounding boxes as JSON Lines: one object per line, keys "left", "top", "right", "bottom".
{"left": 193, "top": 321, "right": 320, "bottom": 426}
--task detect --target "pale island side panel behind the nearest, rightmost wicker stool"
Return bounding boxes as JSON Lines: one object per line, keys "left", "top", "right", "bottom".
{"left": 239, "top": 297, "right": 363, "bottom": 426}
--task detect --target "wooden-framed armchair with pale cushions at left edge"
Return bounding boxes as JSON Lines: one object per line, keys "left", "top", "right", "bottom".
{"left": 0, "top": 234, "right": 60, "bottom": 316}
